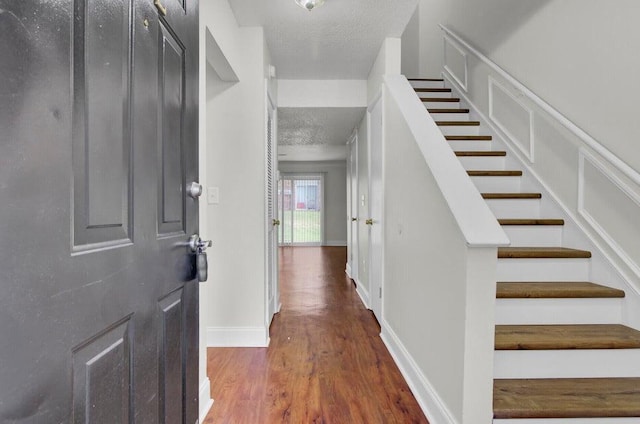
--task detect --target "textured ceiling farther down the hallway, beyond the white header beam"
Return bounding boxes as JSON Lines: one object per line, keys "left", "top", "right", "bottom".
{"left": 278, "top": 108, "right": 366, "bottom": 160}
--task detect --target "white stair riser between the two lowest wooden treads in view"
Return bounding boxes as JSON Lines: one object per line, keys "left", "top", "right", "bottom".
{"left": 493, "top": 349, "right": 640, "bottom": 378}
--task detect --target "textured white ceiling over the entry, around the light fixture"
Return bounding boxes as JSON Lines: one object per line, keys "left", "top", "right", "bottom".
{"left": 229, "top": 0, "right": 418, "bottom": 79}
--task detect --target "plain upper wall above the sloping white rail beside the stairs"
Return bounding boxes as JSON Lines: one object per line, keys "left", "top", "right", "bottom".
{"left": 420, "top": 0, "right": 640, "bottom": 174}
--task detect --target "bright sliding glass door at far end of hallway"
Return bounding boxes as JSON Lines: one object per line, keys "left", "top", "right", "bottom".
{"left": 278, "top": 174, "right": 324, "bottom": 246}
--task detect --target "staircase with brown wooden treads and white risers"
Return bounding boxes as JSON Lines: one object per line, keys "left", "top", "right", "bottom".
{"left": 410, "top": 79, "right": 640, "bottom": 424}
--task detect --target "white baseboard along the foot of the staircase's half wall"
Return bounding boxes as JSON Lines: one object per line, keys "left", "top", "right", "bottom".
{"left": 380, "top": 319, "right": 457, "bottom": 424}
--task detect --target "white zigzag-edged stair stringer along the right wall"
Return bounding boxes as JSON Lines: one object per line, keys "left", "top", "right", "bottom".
{"left": 442, "top": 72, "right": 640, "bottom": 332}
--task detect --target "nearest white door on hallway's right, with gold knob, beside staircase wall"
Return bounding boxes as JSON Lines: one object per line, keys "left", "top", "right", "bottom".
{"left": 367, "top": 96, "right": 384, "bottom": 322}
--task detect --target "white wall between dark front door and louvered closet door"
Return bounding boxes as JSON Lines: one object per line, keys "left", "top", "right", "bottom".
{"left": 200, "top": 0, "right": 276, "bottom": 357}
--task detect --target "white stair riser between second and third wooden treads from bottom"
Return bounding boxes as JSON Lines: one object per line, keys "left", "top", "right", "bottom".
{"left": 496, "top": 298, "right": 622, "bottom": 325}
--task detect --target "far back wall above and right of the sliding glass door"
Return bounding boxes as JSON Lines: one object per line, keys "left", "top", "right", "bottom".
{"left": 278, "top": 161, "right": 347, "bottom": 246}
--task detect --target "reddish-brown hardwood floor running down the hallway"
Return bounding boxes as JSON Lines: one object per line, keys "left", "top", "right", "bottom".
{"left": 204, "top": 247, "right": 427, "bottom": 424}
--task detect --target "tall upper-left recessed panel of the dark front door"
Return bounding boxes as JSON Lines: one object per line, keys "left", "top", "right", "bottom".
{"left": 72, "top": 0, "right": 132, "bottom": 251}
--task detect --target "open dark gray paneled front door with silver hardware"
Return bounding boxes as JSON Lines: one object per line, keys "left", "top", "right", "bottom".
{"left": 0, "top": 0, "right": 198, "bottom": 424}
